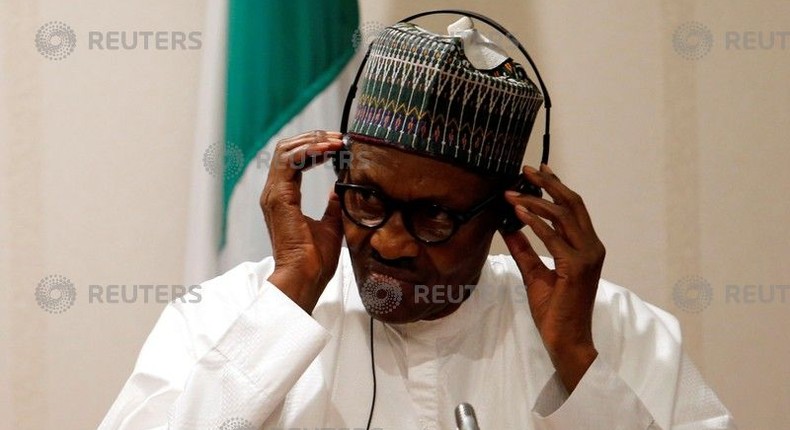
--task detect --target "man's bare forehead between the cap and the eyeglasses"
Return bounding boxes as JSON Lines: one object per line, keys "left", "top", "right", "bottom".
{"left": 349, "top": 143, "right": 493, "bottom": 207}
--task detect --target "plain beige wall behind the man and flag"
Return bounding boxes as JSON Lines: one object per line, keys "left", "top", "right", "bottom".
{"left": 0, "top": 0, "right": 790, "bottom": 430}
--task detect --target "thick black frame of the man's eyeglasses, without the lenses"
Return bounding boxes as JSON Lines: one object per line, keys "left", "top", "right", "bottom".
{"left": 335, "top": 181, "right": 500, "bottom": 245}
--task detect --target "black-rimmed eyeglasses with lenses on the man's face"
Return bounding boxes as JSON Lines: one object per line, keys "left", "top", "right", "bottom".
{"left": 335, "top": 181, "right": 499, "bottom": 245}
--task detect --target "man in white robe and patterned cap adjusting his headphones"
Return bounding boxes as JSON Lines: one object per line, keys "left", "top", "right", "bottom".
{"left": 100, "top": 18, "right": 734, "bottom": 430}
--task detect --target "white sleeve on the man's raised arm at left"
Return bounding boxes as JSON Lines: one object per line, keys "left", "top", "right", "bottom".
{"left": 99, "top": 281, "right": 330, "bottom": 430}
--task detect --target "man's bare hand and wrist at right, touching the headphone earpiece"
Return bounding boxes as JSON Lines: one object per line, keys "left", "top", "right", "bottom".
{"left": 503, "top": 164, "right": 606, "bottom": 392}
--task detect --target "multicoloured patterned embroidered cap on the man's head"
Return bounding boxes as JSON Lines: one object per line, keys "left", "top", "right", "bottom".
{"left": 349, "top": 19, "right": 543, "bottom": 176}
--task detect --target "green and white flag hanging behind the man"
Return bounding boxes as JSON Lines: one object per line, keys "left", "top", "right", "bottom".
{"left": 185, "top": 0, "right": 359, "bottom": 283}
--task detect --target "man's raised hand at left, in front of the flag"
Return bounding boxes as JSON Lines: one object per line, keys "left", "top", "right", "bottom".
{"left": 260, "top": 130, "right": 343, "bottom": 313}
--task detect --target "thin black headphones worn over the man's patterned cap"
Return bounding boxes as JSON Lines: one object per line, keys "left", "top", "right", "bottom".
{"left": 332, "top": 9, "right": 551, "bottom": 233}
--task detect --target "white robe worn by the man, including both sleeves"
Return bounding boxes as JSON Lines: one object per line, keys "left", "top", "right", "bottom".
{"left": 99, "top": 249, "right": 735, "bottom": 430}
